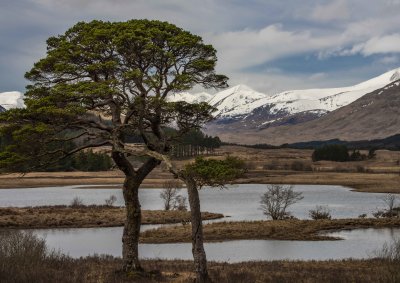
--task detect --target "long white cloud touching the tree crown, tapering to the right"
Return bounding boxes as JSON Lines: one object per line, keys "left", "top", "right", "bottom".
{"left": 207, "top": 25, "right": 342, "bottom": 70}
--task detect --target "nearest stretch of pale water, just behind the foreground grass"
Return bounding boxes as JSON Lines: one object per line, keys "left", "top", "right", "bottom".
{"left": 33, "top": 227, "right": 400, "bottom": 262}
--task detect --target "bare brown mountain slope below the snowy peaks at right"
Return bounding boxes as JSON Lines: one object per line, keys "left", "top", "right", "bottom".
{"left": 207, "top": 79, "right": 400, "bottom": 145}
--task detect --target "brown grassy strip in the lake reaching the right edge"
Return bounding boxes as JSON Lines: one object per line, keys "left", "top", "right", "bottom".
{"left": 141, "top": 218, "right": 400, "bottom": 243}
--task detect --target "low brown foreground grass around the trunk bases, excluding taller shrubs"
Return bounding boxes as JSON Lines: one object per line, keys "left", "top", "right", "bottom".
{"left": 2, "top": 253, "right": 400, "bottom": 283}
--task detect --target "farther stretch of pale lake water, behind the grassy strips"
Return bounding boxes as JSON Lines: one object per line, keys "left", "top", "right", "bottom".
{"left": 0, "top": 184, "right": 390, "bottom": 221}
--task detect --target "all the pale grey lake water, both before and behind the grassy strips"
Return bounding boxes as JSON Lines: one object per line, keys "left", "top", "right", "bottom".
{"left": 0, "top": 184, "right": 400, "bottom": 262}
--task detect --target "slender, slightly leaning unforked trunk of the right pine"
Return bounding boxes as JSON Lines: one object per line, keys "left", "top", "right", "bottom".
{"left": 185, "top": 177, "right": 211, "bottom": 283}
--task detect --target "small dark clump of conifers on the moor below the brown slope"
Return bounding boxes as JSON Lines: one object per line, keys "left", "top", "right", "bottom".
{"left": 312, "top": 144, "right": 375, "bottom": 162}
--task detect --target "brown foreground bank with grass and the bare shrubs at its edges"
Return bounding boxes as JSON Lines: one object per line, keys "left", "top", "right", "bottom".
{"left": 0, "top": 231, "right": 400, "bottom": 283}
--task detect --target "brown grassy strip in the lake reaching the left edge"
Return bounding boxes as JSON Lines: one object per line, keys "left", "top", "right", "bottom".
{"left": 0, "top": 206, "right": 223, "bottom": 231}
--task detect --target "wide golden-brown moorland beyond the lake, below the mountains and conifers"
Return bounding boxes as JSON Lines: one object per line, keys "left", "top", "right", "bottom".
{"left": 0, "top": 146, "right": 400, "bottom": 193}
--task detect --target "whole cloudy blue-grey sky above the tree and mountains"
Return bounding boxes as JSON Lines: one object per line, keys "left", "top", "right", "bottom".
{"left": 0, "top": 0, "right": 400, "bottom": 93}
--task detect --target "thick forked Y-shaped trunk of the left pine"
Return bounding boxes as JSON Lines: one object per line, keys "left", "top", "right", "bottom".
{"left": 112, "top": 152, "right": 160, "bottom": 272}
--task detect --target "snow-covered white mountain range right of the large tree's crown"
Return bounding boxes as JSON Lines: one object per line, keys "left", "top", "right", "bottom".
{"left": 171, "top": 68, "right": 400, "bottom": 127}
